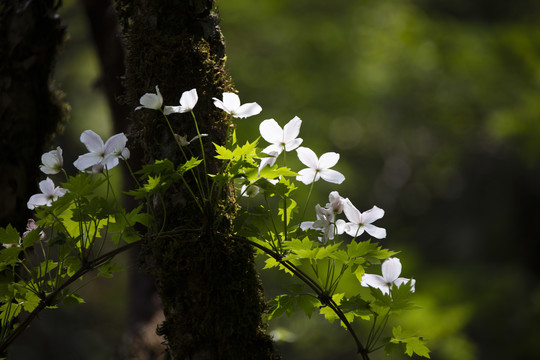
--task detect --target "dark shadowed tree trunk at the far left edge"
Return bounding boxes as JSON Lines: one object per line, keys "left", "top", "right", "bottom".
{"left": 0, "top": 0, "right": 69, "bottom": 230}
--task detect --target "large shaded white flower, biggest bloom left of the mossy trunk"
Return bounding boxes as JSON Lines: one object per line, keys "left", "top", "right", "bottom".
{"left": 73, "top": 130, "right": 130, "bottom": 173}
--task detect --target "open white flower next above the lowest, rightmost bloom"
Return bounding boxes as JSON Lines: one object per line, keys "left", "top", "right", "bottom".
{"left": 343, "top": 199, "right": 386, "bottom": 239}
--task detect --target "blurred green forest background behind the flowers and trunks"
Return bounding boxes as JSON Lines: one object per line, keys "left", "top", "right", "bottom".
{"left": 8, "top": 0, "right": 540, "bottom": 360}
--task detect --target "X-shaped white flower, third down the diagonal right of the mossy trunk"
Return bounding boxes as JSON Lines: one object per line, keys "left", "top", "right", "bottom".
{"left": 296, "top": 147, "right": 345, "bottom": 185}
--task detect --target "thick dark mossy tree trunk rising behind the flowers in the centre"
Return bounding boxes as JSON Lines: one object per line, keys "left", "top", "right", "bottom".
{"left": 113, "top": 0, "right": 277, "bottom": 359}
